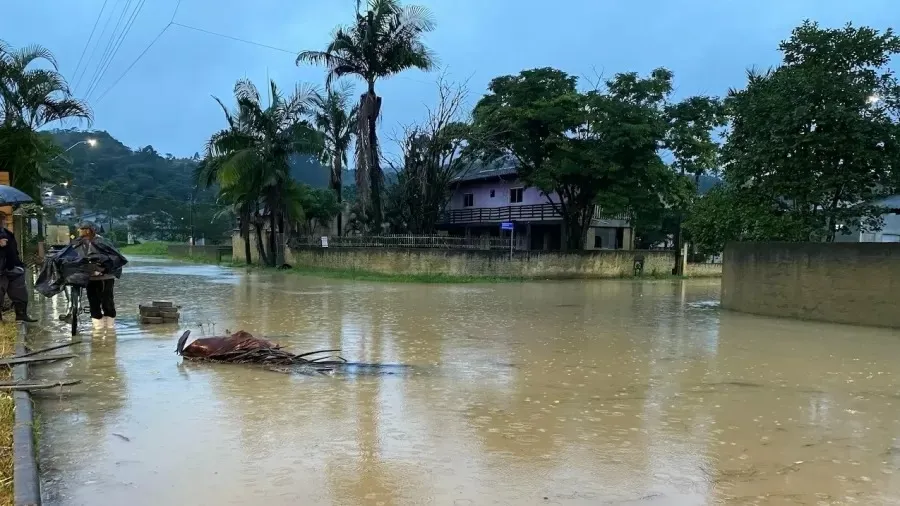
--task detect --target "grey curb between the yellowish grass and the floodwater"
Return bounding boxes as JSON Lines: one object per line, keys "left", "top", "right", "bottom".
{"left": 13, "top": 323, "right": 41, "bottom": 506}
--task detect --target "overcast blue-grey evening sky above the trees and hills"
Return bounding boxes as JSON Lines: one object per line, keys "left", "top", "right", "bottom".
{"left": 0, "top": 0, "right": 900, "bottom": 156}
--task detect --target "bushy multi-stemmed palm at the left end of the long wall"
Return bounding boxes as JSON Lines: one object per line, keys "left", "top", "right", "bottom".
{"left": 196, "top": 79, "right": 322, "bottom": 266}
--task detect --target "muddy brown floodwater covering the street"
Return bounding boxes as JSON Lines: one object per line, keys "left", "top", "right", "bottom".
{"left": 24, "top": 259, "right": 900, "bottom": 506}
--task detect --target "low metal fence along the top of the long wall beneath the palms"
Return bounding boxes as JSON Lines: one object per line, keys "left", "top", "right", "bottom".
{"left": 288, "top": 234, "right": 525, "bottom": 250}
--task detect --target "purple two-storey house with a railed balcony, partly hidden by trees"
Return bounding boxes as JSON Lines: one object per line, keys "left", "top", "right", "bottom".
{"left": 439, "top": 159, "right": 633, "bottom": 251}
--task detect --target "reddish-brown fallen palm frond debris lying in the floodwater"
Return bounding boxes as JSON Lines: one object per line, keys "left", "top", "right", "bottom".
{"left": 175, "top": 330, "right": 347, "bottom": 366}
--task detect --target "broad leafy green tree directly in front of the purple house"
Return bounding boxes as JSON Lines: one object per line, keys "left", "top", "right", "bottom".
{"left": 474, "top": 68, "right": 672, "bottom": 250}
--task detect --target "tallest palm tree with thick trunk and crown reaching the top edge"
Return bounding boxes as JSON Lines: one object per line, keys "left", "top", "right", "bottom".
{"left": 297, "top": 0, "right": 435, "bottom": 227}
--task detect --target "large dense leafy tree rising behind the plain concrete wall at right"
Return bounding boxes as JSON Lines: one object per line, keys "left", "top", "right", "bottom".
{"left": 716, "top": 21, "right": 900, "bottom": 242}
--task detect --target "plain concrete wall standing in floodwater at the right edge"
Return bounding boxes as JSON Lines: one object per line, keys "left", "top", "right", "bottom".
{"left": 722, "top": 243, "right": 900, "bottom": 327}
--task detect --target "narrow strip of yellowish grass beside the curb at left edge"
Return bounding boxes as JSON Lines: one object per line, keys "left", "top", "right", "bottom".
{"left": 0, "top": 313, "right": 16, "bottom": 506}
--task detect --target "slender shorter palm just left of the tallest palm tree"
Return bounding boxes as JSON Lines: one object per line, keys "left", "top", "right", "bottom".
{"left": 311, "top": 83, "right": 359, "bottom": 236}
